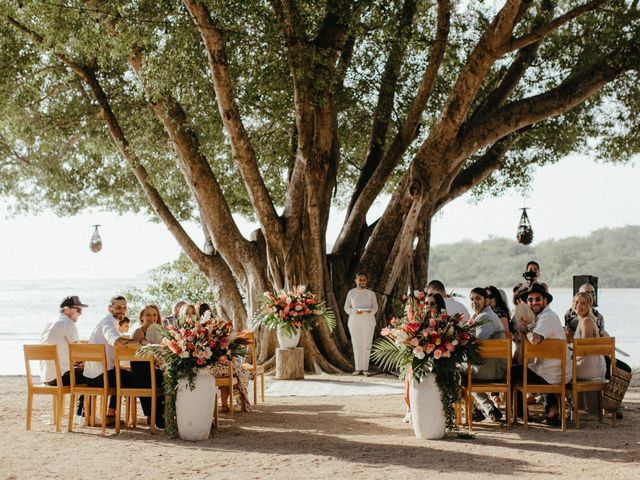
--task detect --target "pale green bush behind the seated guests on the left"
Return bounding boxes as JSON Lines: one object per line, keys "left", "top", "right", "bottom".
{"left": 125, "top": 254, "right": 215, "bottom": 312}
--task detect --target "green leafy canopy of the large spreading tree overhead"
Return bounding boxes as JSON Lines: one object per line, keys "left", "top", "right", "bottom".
{"left": 0, "top": 0, "right": 640, "bottom": 220}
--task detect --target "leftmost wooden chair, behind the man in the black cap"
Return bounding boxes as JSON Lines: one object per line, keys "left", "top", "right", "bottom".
{"left": 22, "top": 345, "right": 73, "bottom": 432}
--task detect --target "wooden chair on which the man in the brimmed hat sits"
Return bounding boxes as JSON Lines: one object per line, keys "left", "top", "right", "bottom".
{"left": 513, "top": 338, "right": 567, "bottom": 432}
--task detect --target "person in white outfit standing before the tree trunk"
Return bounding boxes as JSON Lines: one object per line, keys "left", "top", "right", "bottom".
{"left": 344, "top": 273, "right": 378, "bottom": 376}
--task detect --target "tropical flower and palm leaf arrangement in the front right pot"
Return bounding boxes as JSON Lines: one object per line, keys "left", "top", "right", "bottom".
{"left": 371, "top": 292, "right": 479, "bottom": 430}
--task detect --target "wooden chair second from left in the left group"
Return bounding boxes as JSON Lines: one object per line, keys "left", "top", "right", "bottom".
{"left": 69, "top": 343, "right": 116, "bottom": 434}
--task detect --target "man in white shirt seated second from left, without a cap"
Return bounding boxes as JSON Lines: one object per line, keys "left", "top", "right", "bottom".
{"left": 84, "top": 296, "right": 164, "bottom": 428}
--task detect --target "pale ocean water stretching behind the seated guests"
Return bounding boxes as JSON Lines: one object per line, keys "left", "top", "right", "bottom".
{"left": 0, "top": 279, "right": 640, "bottom": 375}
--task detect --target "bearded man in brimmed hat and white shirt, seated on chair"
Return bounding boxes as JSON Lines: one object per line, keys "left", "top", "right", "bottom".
{"left": 511, "top": 283, "right": 571, "bottom": 425}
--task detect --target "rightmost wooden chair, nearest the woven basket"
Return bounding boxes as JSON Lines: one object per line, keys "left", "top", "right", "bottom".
{"left": 571, "top": 337, "right": 617, "bottom": 430}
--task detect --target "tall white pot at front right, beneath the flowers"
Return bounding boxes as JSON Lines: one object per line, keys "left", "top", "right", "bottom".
{"left": 409, "top": 374, "right": 447, "bottom": 440}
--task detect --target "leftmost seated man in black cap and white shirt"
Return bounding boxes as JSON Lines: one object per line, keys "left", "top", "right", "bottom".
{"left": 40, "top": 295, "right": 88, "bottom": 415}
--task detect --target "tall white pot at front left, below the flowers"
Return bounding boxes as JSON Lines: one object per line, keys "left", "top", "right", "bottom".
{"left": 176, "top": 368, "right": 218, "bottom": 441}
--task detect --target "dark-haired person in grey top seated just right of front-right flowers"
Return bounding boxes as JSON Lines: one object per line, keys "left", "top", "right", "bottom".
{"left": 463, "top": 287, "right": 507, "bottom": 422}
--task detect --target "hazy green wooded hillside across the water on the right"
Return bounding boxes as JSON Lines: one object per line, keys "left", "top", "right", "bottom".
{"left": 429, "top": 226, "right": 640, "bottom": 288}
